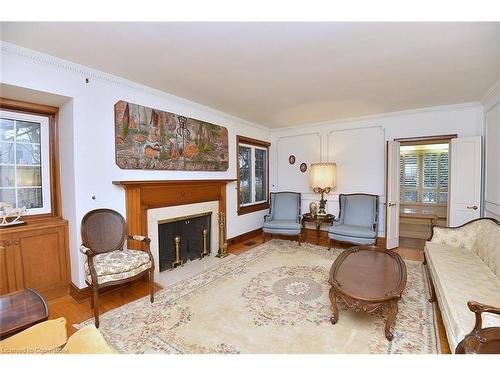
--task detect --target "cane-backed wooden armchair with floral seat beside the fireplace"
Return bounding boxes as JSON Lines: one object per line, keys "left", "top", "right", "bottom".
{"left": 80, "top": 208, "right": 154, "bottom": 327}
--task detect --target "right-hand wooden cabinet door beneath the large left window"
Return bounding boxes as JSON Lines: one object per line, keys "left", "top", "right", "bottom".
{"left": 12, "top": 227, "right": 68, "bottom": 298}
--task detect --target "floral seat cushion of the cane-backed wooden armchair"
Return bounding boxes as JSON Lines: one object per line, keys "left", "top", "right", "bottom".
{"left": 83, "top": 250, "right": 151, "bottom": 284}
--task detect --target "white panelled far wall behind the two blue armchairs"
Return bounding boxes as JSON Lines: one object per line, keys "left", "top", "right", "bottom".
{"left": 271, "top": 103, "right": 483, "bottom": 236}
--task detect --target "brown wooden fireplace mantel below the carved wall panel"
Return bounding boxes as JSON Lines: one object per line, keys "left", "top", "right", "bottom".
{"left": 113, "top": 179, "right": 236, "bottom": 249}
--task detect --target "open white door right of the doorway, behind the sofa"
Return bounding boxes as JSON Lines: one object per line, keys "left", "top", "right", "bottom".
{"left": 448, "top": 136, "right": 481, "bottom": 227}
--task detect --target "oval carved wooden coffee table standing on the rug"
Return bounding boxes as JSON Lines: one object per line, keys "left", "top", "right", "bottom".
{"left": 329, "top": 246, "right": 406, "bottom": 341}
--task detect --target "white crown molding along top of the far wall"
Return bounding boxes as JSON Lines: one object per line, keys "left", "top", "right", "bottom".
{"left": 271, "top": 102, "right": 481, "bottom": 132}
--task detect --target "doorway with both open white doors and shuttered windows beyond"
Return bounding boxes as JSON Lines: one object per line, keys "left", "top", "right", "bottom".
{"left": 385, "top": 135, "right": 481, "bottom": 249}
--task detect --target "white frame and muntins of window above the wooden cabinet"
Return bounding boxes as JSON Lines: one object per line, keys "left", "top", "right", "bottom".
{"left": 0, "top": 110, "right": 52, "bottom": 215}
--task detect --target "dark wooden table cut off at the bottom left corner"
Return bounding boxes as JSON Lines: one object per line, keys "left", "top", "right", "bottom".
{"left": 0, "top": 289, "right": 49, "bottom": 339}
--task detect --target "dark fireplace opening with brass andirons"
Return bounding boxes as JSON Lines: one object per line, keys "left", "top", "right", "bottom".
{"left": 158, "top": 212, "right": 212, "bottom": 272}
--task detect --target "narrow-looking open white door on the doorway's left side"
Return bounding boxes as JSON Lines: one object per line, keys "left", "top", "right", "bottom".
{"left": 385, "top": 141, "right": 400, "bottom": 249}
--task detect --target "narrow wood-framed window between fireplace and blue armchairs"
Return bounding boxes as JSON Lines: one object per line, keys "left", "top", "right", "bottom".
{"left": 237, "top": 136, "right": 270, "bottom": 215}
